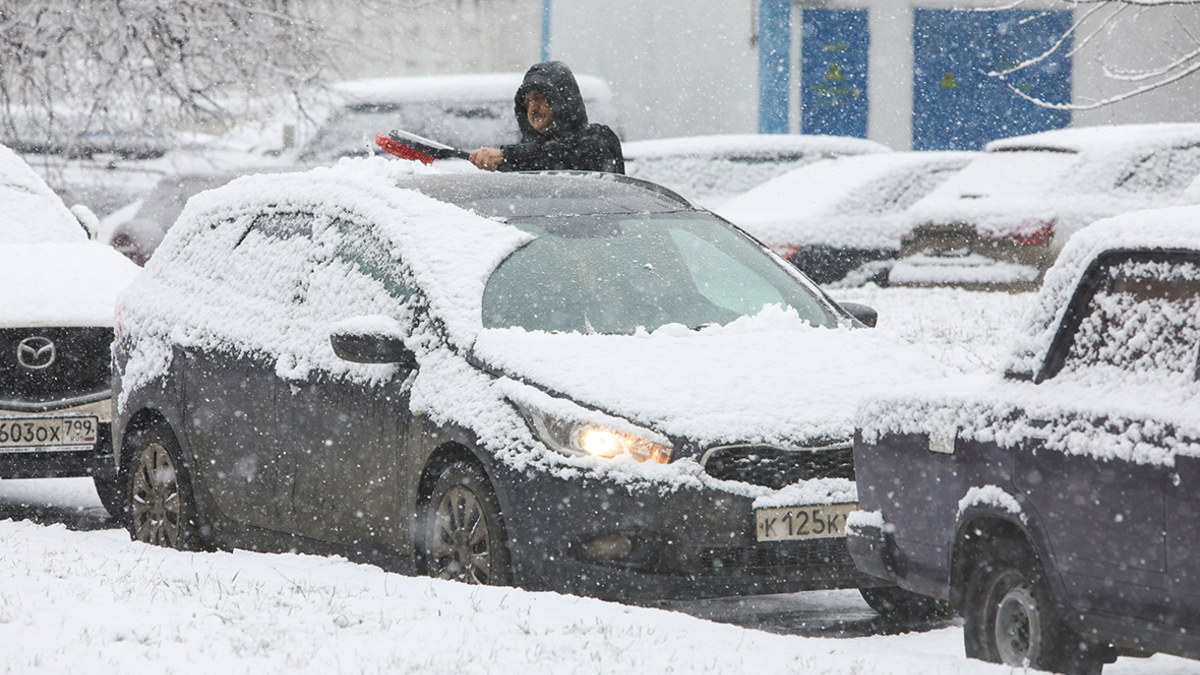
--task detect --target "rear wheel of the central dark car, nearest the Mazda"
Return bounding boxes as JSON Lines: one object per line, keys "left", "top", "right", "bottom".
{"left": 128, "top": 426, "right": 202, "bottom": 550}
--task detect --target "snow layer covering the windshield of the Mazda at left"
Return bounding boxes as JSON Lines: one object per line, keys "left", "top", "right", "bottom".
{"left": 0, "top": 145, "right": 88, "bottom": 244}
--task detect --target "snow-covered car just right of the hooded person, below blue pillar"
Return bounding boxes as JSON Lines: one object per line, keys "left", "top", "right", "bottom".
{"left": 623, "top": 133, "right": 892, "bottom": 209}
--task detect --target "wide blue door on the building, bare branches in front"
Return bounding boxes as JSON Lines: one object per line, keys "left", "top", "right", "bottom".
{"left": 912, "top": 8, "right": 1072, "bottom": 150}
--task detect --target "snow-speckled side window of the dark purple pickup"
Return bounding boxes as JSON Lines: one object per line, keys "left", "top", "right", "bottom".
{"left": 1062, "top": 252, "right": 1200, "bottom": 380}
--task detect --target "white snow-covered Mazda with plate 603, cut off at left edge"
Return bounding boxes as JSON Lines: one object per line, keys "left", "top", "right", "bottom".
{"left": 0, "top": 145, "right": 138, "bottom": 515}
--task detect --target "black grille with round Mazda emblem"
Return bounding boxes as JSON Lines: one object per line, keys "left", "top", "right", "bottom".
{"left": 0, "top": 328, "right": 113, "bottom": 405}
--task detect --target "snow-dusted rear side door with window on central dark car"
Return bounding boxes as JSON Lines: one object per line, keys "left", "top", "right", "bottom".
{"left": 184, "top": 213, "right": 311, "bottom": 532}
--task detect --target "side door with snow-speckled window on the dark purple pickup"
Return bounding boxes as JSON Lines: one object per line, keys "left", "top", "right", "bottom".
{"left": 1016, "top": 252, "right": 1200, "bottom": 621}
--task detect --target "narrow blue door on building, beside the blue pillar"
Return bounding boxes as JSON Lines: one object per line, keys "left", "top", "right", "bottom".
{"left": 800, "top": 10, "right": 870, "bottom": 138}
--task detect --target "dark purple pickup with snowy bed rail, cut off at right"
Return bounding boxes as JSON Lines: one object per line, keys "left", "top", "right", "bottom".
{"left": 850, "top": 207, "right": 1200, "bottom": 673}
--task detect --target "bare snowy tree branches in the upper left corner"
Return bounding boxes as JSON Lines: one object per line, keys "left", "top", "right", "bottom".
{"left": 0, "top": 0, "right": 331, "bottom": 153}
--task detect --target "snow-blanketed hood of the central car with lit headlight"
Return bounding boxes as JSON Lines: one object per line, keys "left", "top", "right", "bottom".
{"left": 473, "top": 307, "right": 944, "bottom": 446}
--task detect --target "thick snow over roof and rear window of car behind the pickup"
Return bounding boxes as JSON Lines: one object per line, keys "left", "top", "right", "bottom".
{"left": 906, "top": 124, "right": 1200, "bottom": 243}
